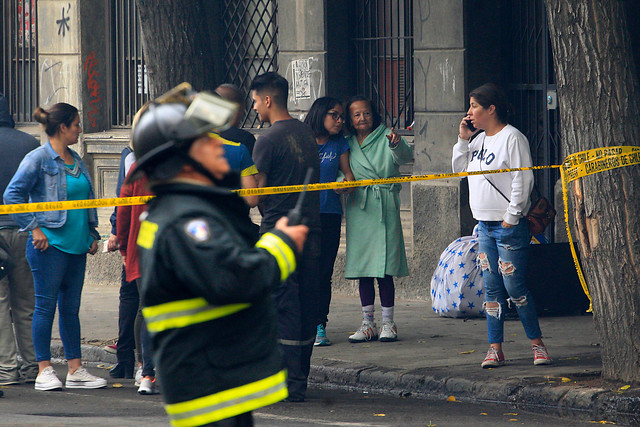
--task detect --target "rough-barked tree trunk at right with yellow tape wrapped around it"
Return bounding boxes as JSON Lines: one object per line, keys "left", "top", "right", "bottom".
{"left": 546, "top": 0, "right": 640, "bottom": 382}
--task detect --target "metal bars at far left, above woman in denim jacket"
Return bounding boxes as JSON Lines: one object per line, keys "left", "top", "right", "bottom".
{"left": 0, "top": 0, "right": 38, "bottom": 122}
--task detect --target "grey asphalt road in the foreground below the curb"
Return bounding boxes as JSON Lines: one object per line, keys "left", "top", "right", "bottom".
{"left": 0, "top": 366, "right": 600, "bottom": 427}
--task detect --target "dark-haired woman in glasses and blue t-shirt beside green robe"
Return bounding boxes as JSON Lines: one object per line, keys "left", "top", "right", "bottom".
{"left": 304, "top": 96, "right": 354, "bottom": 346}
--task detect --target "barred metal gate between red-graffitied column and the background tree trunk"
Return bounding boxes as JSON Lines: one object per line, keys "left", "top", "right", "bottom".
{"left": 111, "top": 0, "right": 149, "bottom": 126}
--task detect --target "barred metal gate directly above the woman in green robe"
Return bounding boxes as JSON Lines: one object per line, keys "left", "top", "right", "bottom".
{"left": 353, "top": 0, "right": 413, "bottom": 129}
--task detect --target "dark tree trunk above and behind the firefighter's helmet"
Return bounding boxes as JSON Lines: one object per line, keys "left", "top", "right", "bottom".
{"left": 136, "top": 0, "right": 219, "bottom": 98}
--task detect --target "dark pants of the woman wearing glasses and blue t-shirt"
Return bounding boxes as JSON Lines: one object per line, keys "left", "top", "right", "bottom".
{"left": 316, "top": 214, "right": 342, "bottom": 324}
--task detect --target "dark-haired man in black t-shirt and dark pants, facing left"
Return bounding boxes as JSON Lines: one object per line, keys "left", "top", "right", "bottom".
{"left": 251, "top": 73, "right": 320, "bottom": 402}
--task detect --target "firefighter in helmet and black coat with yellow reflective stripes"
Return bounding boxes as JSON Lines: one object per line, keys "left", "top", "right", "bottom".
{"left": 131, "top": 98, "right": 308, "bottom": 426}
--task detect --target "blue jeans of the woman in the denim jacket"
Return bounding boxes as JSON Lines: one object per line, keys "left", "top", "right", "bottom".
{"left": 26, "top": 237, "right": 87, "bottom": 362}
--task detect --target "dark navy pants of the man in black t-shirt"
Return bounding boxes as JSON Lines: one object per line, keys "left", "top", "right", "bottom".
{"left": 273, "top": 232, "right": 320, "bottom": 400}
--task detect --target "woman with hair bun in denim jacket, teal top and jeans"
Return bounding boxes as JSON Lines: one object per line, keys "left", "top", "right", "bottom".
{"left": 4, "top": 103, "right": 107, "bottom": 390}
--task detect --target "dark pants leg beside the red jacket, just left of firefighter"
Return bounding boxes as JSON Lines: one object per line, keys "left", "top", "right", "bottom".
{"left": 116, "top": 265, "right": 140, "bottom": 366}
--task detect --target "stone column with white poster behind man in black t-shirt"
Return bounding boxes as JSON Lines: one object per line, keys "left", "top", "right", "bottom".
{"left": 277, "top": 0, "right": 327, "bottom": 118}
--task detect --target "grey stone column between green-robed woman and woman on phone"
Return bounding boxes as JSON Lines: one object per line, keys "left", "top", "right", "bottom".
{"left": 407, "top": 0, "right": 470, "bottom": 290}
